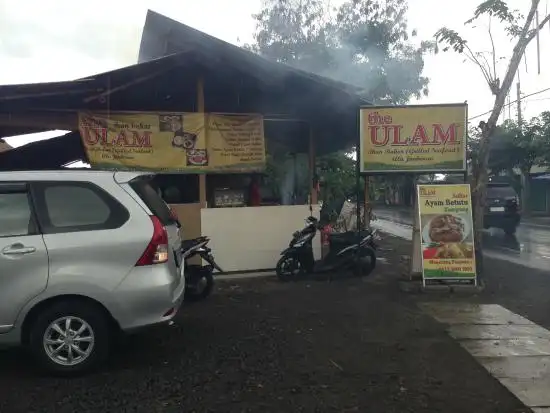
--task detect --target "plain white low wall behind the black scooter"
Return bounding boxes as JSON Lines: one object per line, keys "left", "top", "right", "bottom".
{"left": 201, "top": 205, "right": 321, "bottom": 271}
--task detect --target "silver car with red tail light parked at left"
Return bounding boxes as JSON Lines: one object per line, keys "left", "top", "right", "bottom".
{"left": 0, "top": 170, "right": 185, "bottom": 375}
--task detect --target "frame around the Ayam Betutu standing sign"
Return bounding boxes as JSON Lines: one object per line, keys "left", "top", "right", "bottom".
{"left": 416, "top": 183, "right": 478, "bottom": 287}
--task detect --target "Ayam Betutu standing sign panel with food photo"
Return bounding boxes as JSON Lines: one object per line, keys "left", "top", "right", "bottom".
{"left": 418, "top": 184, "right": 476, "bottom": 284}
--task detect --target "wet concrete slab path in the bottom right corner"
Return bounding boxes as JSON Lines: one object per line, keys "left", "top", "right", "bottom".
{"left": 420, "top": 302, "right": 550, "bottom": 412}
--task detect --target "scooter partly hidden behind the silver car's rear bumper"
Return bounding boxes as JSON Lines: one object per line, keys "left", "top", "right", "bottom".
{"left": 181, "top": 236, "right": 222, "bottom": 301}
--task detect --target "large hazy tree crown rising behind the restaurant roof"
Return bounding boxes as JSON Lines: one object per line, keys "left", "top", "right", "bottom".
{"left": 247, "top": 0, "right": 435, "bottom": 103}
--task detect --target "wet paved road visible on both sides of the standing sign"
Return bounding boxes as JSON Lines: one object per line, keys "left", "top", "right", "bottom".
{"left": 374, "top": 209, "right": 550, "bottom": 270}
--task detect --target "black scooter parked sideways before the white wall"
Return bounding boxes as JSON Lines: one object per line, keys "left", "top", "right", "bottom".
{"left": 276, "top": 216, "right": 376, "bottom": 281}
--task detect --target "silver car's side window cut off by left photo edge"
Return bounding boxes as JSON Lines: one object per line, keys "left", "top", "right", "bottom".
{"left": 0, "top": 193, "right": 31, "bottom": 237}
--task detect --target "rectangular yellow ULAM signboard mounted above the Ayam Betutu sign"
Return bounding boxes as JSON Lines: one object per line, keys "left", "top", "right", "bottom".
{"left": 360, "top": 103, "right": 468, "bottom": 174}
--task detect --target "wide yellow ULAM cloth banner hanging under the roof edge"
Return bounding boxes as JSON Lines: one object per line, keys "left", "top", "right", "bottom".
{"left": 78, "top": 112, "right": 265, "bottom": 173}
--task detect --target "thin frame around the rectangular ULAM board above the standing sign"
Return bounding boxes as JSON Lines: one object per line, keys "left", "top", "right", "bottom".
{"left": 358, "top": 102, "right": 468, "bottom": 175}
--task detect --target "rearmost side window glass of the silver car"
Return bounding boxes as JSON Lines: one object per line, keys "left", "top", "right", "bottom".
{"left": 44, "top": 185, "right": 111, "bottom": 228}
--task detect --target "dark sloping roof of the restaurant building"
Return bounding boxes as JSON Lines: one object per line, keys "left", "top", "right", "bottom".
{"left": 0, "top": 11, "right": 369, "bottom": 153}
